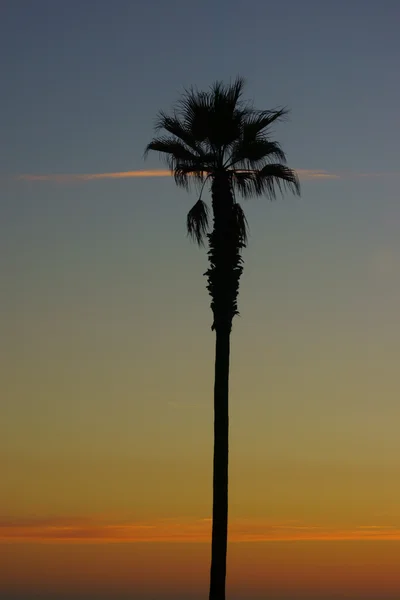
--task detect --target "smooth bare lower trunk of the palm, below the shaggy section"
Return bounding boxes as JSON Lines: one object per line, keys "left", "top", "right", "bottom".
{"left": 209, "top": 327, "right": 230, "bottom": 600}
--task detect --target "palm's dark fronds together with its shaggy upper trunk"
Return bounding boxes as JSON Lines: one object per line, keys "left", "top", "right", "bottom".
{"left": 145, "top": 77, "right": 300, "bottom": 328}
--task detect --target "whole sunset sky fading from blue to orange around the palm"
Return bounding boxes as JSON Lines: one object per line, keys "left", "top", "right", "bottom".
{"left": 0, "top": 0, "right": 400, "bottom": 600}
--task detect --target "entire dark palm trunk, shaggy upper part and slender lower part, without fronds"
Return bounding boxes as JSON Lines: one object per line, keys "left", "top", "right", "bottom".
{"left": 206, "top": 172, "right": 244, "bottom": 600}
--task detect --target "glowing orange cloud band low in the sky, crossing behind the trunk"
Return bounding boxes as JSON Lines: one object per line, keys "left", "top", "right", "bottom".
{"left": 0, "top": 518, "right": 400, "bottom": 544}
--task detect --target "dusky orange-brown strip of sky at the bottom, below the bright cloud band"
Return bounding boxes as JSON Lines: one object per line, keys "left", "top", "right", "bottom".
{"left": 0, "top": 541, "right": 400, "bottom": 599}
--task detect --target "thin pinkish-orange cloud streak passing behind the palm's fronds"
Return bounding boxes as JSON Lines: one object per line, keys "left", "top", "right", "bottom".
{"left": 15, "top": 169, "right": 342, "bottom": 183}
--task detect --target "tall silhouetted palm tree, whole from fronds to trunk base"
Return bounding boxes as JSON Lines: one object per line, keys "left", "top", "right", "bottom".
{"left": 145, "top": 78, "right": 300, "bottom": 600}
